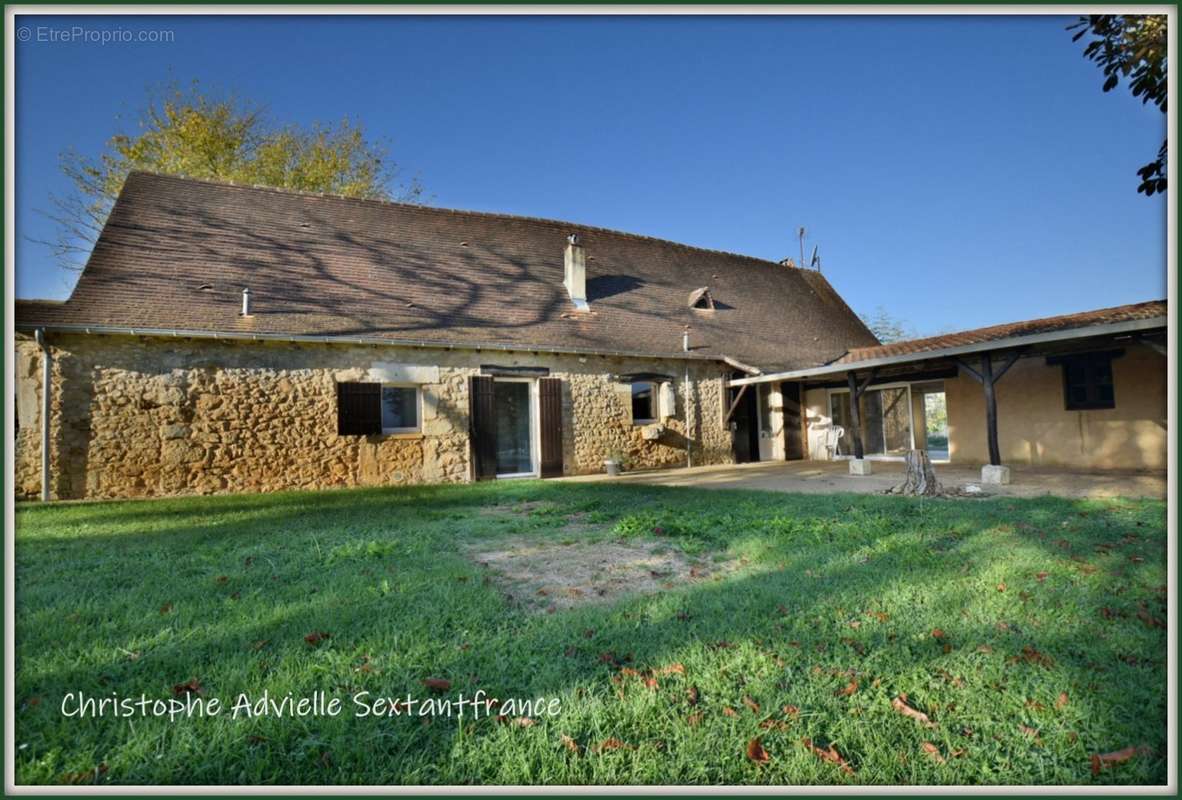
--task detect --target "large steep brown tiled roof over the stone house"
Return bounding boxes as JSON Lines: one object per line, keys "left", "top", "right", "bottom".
{"left": 17, "top": 173, "right": 876, "bottom": 369}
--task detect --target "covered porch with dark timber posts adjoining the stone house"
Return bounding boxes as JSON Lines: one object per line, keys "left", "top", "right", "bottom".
{"left": 726, "top": 301, "right": 1168, "bottom": 484}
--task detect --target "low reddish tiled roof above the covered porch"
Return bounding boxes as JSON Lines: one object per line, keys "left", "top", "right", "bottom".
{"left": 834, "top": 300, "right": 1165, "bottom": 364}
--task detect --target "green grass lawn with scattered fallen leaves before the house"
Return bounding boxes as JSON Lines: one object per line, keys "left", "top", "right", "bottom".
{"left": 15, "top": 482, "right": 1167, "bottom": 783}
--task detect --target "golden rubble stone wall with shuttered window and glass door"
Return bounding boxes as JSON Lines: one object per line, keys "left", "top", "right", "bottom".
{"left": 15, "top": 334, "right": 732, "bottom": 499}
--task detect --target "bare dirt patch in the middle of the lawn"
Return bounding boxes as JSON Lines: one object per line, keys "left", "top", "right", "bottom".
{"left": 469, "top": 538, "right": 729, "bottom": 611}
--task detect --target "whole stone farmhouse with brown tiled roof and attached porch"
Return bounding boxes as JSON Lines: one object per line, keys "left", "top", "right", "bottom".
{"left": 14, "top": 173, "right": 1168, "bottom": 499}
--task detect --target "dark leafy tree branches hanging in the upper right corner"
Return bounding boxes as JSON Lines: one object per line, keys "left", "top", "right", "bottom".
{"left": 1067, "top": 14, "right": 1168, "bottom": 196}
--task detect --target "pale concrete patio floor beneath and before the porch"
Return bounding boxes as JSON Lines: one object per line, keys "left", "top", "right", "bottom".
{"left": 561, "top": 461, "right": 1167, "bottom": 499}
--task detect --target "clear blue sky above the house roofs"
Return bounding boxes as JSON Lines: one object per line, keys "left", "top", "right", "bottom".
{"left": 15, "top": 17, "right": 1165, "bottom": 332}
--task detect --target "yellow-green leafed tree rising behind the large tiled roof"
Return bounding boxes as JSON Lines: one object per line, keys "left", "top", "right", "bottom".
{"left": 41, "top": 82, "right": 422, "bottom": 269}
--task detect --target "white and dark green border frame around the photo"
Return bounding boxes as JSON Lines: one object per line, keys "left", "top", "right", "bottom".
{"left": 4, "top": 5, "right": 1178, "bottom": 796}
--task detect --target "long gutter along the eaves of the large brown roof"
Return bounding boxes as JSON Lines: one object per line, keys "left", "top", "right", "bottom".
{"left": 15, "top": 325, "right": 728, "bottom": 362}
